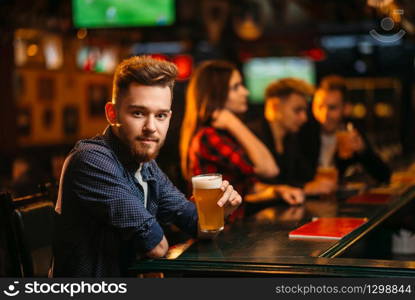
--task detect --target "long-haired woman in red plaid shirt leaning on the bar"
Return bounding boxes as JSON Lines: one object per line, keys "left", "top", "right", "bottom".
{"left": 180, "top": 60, "right": 304, "bottom": 204}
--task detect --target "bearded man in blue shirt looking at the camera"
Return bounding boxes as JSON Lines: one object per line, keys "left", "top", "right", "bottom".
{"left": 53, "top": 56, "right": 242, "bottom": 277}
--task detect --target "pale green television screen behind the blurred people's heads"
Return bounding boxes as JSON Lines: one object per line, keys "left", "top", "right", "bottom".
{"left": 243, "top": 57, "right": 315, "bottom": 103}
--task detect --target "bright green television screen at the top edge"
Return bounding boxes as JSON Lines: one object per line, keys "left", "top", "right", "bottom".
{"left": 72, "top": 0, "right": 175, "bottom": 28}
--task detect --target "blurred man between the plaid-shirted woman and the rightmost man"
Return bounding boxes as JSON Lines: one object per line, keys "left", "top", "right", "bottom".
{"left": 250, "top": 78, "right": 336, "bottom": 195}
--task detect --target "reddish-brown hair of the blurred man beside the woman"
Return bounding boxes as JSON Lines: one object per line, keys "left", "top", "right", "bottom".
{"left": 265, "top": 78, "right": 314, "bottom": 100}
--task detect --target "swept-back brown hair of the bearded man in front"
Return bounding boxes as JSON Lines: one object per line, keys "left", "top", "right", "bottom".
{"left": 112, "top": 56, "right": 177, "bottom": 104}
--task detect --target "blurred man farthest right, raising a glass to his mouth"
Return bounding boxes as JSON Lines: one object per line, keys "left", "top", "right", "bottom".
{"left": 300, "top": 75, "right": 391, "bottom": 182}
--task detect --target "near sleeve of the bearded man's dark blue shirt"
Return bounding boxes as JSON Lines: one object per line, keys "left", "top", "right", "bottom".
{"left": 62, "top": 147, "right": 164, "bottom": 251}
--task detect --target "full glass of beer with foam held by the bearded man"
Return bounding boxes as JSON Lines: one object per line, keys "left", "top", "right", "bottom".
{"left": 192, "top": 174, "right": 224, "bottom": 233}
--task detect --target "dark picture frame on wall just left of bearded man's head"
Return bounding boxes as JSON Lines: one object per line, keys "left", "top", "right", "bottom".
{"left": 86, "top": 83, "right": 111, "bottom": 118}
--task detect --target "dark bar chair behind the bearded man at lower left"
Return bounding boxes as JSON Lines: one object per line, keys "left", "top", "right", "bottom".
{"left": 0, "top": 185, "right": 55, "bottom": 277}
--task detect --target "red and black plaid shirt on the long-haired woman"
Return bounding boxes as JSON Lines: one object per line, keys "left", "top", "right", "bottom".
{"left": 189, "top": 127, "right": 255, "bottom": 196}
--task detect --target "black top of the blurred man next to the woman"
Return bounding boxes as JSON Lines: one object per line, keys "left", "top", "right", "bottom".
{"left": 248, "top": 118, "right": 313, "bottom": 187}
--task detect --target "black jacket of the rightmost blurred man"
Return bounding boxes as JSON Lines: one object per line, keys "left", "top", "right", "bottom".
{"left": 299, "top": 119, "right": 391, "bottom": 182}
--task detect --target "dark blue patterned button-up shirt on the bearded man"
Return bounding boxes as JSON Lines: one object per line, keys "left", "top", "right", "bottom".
{"left": 54, "top": 128, "right": 197, "bottom": 277}
